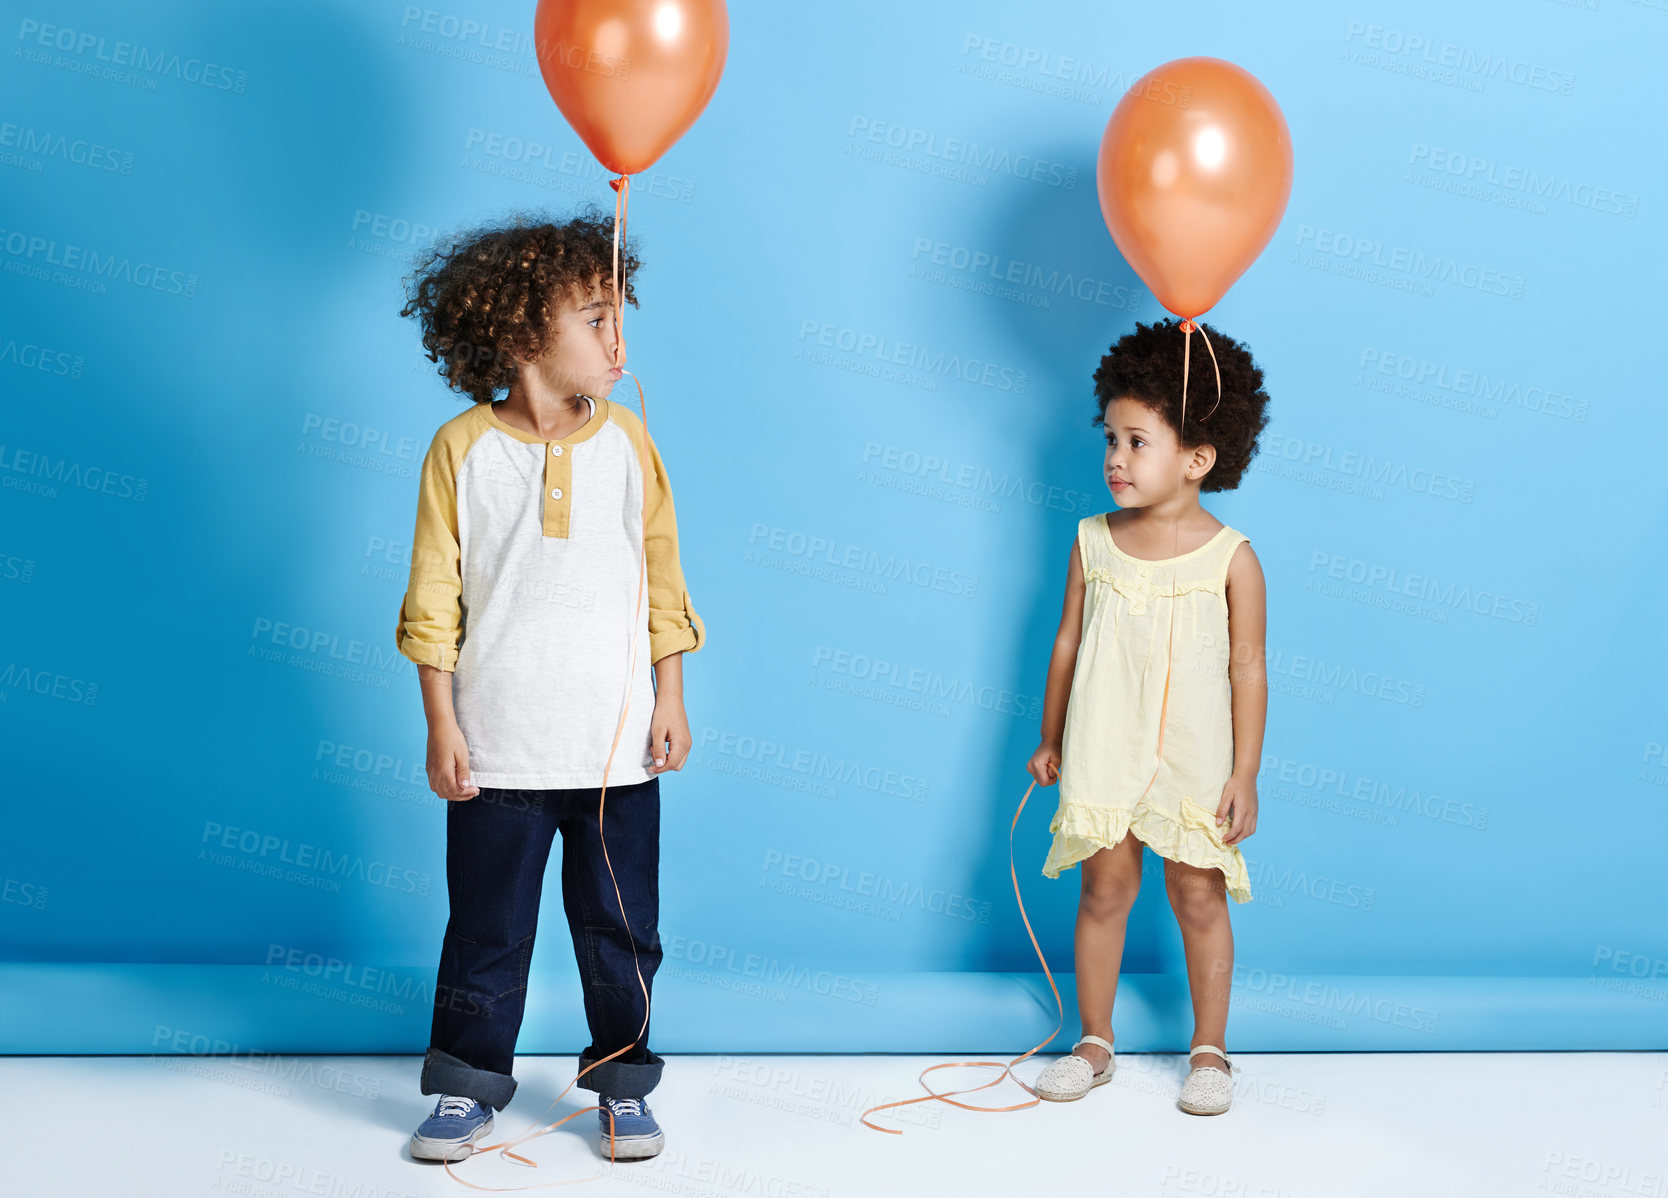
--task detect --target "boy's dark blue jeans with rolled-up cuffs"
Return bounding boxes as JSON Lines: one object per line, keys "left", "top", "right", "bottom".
{"left": 420, "top": 778, "right": 666, "bottom": 1110}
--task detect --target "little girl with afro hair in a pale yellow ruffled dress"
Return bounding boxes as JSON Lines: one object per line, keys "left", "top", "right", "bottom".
{"left": 1027, "top": 319, "right": 1268, "bottom": 1115}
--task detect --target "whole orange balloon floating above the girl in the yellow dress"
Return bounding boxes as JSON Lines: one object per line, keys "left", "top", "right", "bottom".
{"left": 1094, "top": 57, "right": 1291, "bottom": 317}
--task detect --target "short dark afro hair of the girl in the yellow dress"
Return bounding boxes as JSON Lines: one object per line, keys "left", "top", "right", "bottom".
{"left": 1091, "top": 317, "right": 1268, "bottom": 491}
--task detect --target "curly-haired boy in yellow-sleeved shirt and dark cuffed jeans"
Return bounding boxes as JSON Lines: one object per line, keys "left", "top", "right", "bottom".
{"left": 395, "top": 210, "right": 706, "bottom": 1160}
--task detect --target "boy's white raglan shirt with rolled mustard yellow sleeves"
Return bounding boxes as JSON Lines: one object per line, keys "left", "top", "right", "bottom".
{"left": 395, "top": 397, "right": 706, "bottom": 789}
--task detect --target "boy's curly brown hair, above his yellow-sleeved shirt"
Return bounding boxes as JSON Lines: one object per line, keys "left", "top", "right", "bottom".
{"left": 400, "top": 204, "right": 642, "bottom": 404}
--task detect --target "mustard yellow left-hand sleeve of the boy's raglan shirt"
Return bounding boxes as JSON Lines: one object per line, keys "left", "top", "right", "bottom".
{"left": 394, "top": 427, "right": 464, "bottom": 671}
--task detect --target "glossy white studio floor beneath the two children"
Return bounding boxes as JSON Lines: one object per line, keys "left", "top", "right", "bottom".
{"left": 0, "top": 1051, "right": 1668, "bottom": 1198}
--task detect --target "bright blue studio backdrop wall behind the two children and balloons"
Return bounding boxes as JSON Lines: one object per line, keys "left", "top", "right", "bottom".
{"left": 0, "top": 0, "right": 1668, "bottom": 1051}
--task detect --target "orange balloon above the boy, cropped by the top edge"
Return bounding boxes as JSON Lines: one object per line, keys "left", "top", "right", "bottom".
{"left": 532, "top": 0, "right": 729, "bottom": 175}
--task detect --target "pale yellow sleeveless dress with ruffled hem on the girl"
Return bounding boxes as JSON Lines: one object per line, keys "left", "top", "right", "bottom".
{"left": 1043, "top": 512, "right": 1251, "bottom": 903}
